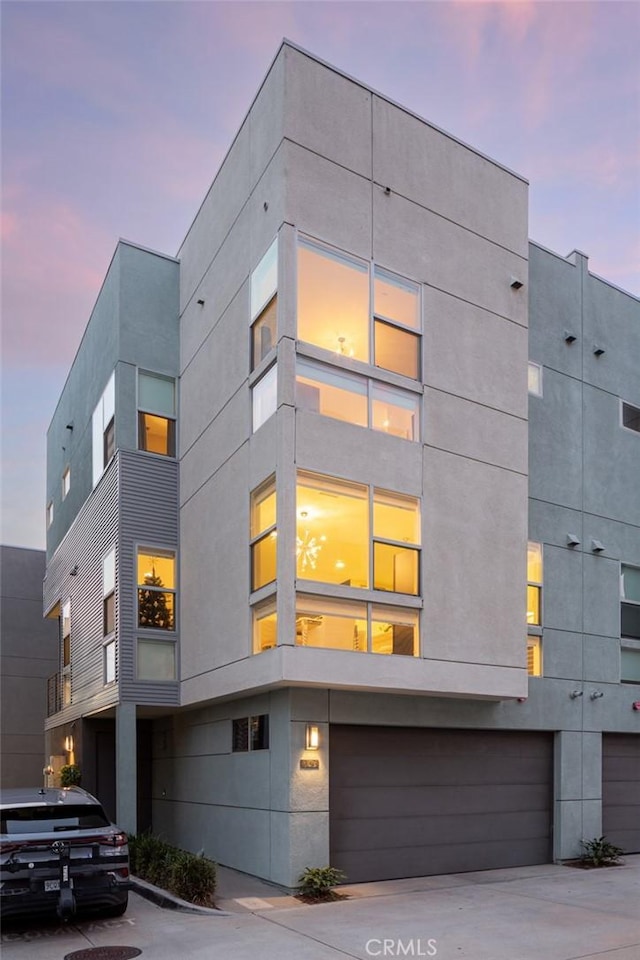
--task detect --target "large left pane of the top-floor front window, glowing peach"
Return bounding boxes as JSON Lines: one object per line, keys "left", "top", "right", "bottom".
{"left": 298, "top": 240, "right": 370, "bottom": 363}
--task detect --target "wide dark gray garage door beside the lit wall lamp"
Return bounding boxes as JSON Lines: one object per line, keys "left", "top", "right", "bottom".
{"left": 329, "top": 725, "right": 553, "bottom": 883}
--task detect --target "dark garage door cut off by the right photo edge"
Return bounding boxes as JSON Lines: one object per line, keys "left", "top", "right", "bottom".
{"left": 602, "top": 733, "right": 640, "bottom": 853}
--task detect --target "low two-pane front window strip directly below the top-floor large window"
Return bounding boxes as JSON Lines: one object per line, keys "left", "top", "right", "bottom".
{"left": 296, "top": 359, "right": 420, "bottom": 440}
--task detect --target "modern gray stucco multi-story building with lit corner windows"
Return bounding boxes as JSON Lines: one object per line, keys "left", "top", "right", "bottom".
{"left": 45, "top": 42, "right": 640, "bottom": 885}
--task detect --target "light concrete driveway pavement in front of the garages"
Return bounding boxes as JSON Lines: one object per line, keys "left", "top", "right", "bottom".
{"left": 2, "top": 856, "right": 640, "bottom": 960}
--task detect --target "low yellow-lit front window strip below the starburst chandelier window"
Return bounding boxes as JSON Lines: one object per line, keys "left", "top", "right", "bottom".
{"left": 296, "top": 596, "right": 419, "bottom": 657}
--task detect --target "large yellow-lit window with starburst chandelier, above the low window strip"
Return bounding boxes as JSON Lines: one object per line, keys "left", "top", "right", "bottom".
{"left": 296, "top": 472, "right": 420, "bottom": 595}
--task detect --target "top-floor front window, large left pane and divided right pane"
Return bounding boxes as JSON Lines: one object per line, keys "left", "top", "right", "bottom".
{"left": 298, "top": 239, "right": 420, "bottom": 379}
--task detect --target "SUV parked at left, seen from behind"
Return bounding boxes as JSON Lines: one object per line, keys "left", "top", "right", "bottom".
{"left": 0, "top": 787, "right": 130, "bottom": 919}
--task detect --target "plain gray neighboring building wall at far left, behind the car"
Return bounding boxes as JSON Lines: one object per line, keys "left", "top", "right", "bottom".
{"left": 0, "top": 546, "right": 59, "bottom": 787}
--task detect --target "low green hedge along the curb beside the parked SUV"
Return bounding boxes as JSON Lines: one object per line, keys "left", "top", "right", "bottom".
{"left": 129, "top": 833, "right": 216, "bottom": 905}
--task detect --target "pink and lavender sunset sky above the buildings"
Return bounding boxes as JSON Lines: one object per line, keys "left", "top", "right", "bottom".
{"left": 1, "top": 0, "right": 640, "bottom": 548}
